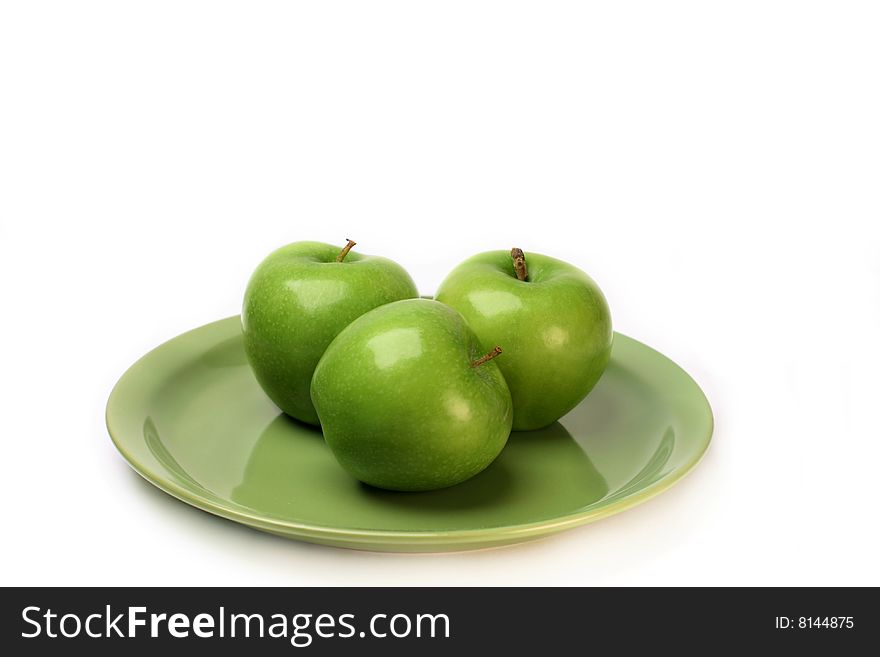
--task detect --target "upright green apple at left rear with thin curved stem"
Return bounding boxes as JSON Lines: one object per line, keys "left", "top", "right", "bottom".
{"left": 241, "top": 240, "right": 418, "bottom": 424}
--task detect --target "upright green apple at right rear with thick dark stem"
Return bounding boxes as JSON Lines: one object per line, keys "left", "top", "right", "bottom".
{"left": 436, "top": 249, "right": 612, "bottom": 431}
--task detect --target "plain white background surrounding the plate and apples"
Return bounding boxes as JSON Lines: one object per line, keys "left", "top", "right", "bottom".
{"left": 0, "top": 0, "right": 880, "bottom": 585}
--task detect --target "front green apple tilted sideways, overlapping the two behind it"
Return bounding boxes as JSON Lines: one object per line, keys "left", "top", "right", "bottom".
{"left": 312, "top": 299, "right": 513, "bottom": 491}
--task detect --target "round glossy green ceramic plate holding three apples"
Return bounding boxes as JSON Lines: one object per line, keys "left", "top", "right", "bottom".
{"left": 107, "top": 317, "right": 712, "bottom": 552}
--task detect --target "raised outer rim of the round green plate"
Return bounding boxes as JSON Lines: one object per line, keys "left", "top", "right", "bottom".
{"left": 104, "top": 315, "right": 715, "bottom": 551}
